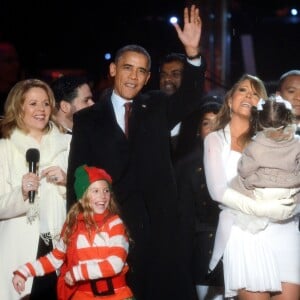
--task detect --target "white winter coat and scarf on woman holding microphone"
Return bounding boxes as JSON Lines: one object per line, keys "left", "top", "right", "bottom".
{"left": 0, "top": 126, "right": 71, "bottom": 300}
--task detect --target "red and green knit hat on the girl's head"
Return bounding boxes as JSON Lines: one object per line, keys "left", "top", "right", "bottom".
{"left": 74, "top": 165, "right": 112, "bottom": 200}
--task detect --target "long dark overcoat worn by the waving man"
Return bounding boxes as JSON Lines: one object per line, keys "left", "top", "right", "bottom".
{"left": 67, "top": 64, "right": 204, "bottom": 300}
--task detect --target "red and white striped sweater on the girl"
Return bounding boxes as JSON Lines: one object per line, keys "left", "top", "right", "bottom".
{"left": 15, "top": 213, "right": 132, "bottom": 300}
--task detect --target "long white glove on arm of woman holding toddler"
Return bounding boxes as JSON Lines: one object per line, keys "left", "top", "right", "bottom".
{"left": 222, "top": 188, "right": 296, "bottom": 221}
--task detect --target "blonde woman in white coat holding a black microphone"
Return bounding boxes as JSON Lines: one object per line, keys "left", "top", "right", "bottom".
{"left": 0, "top": 79, "right": 71, "bottom": 300}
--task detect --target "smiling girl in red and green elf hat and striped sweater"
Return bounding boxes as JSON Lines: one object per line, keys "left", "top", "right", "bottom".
{"left": 12, "top": 165, "right": 133, "bottom": 300}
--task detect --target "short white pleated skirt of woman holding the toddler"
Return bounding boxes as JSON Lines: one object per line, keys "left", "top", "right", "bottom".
{"left": 223, "top": 217, "right": 300, "bottom": 297}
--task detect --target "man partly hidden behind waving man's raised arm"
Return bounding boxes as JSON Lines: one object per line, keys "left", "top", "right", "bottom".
{"left": 159, "top": 53, "right": 202, "bottom": 163}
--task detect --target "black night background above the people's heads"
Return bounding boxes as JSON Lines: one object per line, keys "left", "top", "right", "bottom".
{"left": 0, "top": 0, "right": 300, "bottom": 91}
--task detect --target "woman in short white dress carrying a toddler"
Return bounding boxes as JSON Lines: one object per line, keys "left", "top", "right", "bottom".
{"left": 204, "top": 74, "right": 300, "bottom": 300}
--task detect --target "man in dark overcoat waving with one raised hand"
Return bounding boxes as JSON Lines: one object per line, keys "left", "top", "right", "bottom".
{"left": 67, "top": 5, "right": 204, "bottom": 300}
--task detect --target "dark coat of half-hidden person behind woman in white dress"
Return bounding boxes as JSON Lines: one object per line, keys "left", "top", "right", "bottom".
{"left": 175, "top": 137, "right": 224, "bottom": 286}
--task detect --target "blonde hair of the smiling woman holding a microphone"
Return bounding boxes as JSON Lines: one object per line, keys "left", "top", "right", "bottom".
{"left": 0, "top": 79, "right": 64, "bottom": 138}
